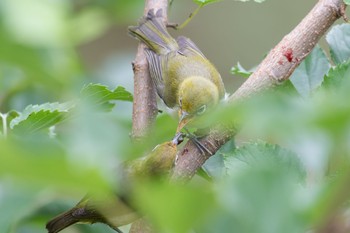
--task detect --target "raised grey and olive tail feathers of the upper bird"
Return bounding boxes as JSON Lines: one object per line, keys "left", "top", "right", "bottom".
{"left": 128, "top": 9, "right": 178, "bottom": 54}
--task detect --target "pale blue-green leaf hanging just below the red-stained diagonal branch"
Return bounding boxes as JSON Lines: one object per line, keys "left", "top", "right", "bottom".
{"left": 290, "top": 45, "right": 330, "bottom": 97}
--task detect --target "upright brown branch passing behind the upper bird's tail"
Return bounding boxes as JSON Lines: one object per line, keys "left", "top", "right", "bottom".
{"left": 132, "top": 0, "right": 168, "bottom": 139}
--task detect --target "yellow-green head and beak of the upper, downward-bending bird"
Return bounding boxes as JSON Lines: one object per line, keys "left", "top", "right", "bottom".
{"left": 177, "top": 76, "right": 219, "bottom": 132}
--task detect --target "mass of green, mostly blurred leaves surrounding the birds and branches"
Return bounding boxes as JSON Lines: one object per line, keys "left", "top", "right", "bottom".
{"left": 0, "top": 0, "right": 350, "bottom": 233}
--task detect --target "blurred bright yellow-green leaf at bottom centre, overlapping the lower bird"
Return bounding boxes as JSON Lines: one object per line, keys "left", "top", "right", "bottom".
{"left": 134, "top": 182, "right": 215, "bottom": 233}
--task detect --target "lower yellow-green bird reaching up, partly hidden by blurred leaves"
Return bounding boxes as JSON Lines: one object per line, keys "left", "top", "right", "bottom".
{"left": 46, "top": 133, "right": 183, "bottom": 233}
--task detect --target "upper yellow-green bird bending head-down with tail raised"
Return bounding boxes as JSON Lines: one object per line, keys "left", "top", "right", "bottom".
{"left": 129, "top": 10, "right": 225, "bottom": 131}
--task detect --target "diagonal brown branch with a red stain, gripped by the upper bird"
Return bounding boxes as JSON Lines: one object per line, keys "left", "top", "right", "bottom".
{"left": 172, "top": 0, "right": 345, "bottom": 180}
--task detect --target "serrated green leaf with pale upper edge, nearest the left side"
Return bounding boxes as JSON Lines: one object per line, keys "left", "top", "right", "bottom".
{"left": 10, "top": 102, "right": 74, "bottom": 134}
